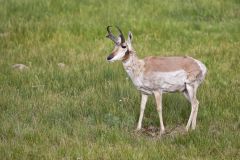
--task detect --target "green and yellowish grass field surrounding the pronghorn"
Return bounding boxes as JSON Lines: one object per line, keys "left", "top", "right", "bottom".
{"left": 0, "top": 0, "right": 240, "bottom": 160}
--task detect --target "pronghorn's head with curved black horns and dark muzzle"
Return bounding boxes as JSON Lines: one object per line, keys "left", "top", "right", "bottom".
{"left": 106, "top": 26, "right": 133, "bottom": 62}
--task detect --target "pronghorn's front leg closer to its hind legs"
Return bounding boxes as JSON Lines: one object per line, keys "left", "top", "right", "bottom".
{"left": 154, "top": 91, "right": 165, "bottom": 134}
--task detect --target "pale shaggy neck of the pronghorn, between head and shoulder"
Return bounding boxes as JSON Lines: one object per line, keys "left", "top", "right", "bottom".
{"left": 123, "top": 51, "right": 144, "bottom": 81}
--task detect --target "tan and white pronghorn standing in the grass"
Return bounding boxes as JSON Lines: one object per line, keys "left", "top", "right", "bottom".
{"left": 106, "top": 26, "right": 207, "bottom": 134}
